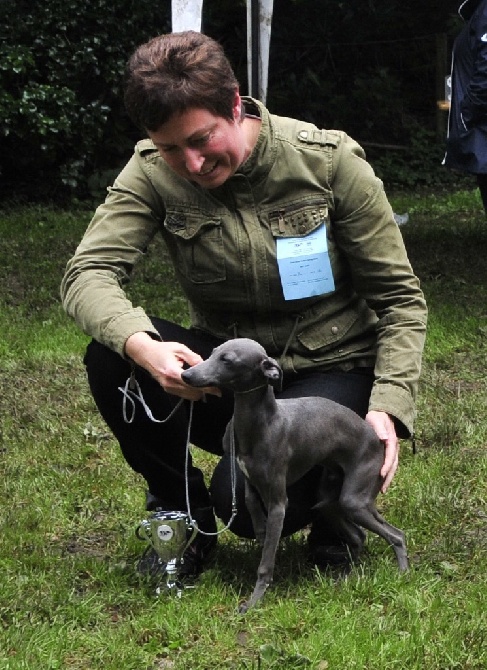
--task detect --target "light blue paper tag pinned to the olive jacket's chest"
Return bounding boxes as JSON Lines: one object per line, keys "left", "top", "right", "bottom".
{"left": 276, "top": 224, "right": 335, "bottom": 300}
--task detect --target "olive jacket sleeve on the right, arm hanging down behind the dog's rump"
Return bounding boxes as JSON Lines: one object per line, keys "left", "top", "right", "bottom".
{"left": 333, "top": 136, "right": 427, "bottom": 437}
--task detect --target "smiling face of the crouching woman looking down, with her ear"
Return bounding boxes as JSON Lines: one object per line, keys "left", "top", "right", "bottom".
{"left": 149, "top": 93, "right": 251, "bottom": 189}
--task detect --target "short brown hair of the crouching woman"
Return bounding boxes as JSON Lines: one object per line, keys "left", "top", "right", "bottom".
{"left": 125, "top": 31, "right": 238, "bottom": 132}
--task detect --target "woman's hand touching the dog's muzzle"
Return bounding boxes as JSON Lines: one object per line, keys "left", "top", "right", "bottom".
{"left": 125, "top": 332, "right": 221, "bottom": 400}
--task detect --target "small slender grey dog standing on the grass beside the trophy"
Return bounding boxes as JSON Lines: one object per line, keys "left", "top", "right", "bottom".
{"left": 182, "top": 338, "right": 408, "bottom": 613}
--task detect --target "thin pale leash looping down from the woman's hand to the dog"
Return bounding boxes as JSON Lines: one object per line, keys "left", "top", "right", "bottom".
{"left": 118, "top": 372, "right": 237, "bottom": 537}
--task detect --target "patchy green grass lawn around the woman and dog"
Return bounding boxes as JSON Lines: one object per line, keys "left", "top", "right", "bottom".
{"left": 0, "top": 191, "right": 487, "bottom": 670}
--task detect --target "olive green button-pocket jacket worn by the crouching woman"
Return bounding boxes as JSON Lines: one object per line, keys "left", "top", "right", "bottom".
{"left": 61, "top": 98, "right": 426, "bottom": 436}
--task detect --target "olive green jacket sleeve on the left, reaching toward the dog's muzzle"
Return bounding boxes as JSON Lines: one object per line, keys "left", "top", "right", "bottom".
{"left": 61, "top": 145, "right": 163, "bottom": 355}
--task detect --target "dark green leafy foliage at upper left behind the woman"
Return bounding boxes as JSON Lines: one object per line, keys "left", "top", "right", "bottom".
{"left": 0, "top": 0, "right": 170, "bottom": 198}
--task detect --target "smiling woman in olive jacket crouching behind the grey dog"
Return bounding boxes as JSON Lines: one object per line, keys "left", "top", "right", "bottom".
{"left": 62, "top": 32, "right": 426, "bottom": 574}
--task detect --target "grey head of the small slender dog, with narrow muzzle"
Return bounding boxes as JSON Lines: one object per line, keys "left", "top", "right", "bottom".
{"left": 181, "top": 338, "right": 282, "bottom": 393}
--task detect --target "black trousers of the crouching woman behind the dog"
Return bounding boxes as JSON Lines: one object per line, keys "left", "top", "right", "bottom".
{"left": 85, "top": 318, "right": 373, "bottom": 538}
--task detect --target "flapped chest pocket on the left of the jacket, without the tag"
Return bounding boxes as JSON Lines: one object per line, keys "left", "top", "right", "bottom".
{"left": 164, "top": 208, "right": 226, "bottom": 284}
